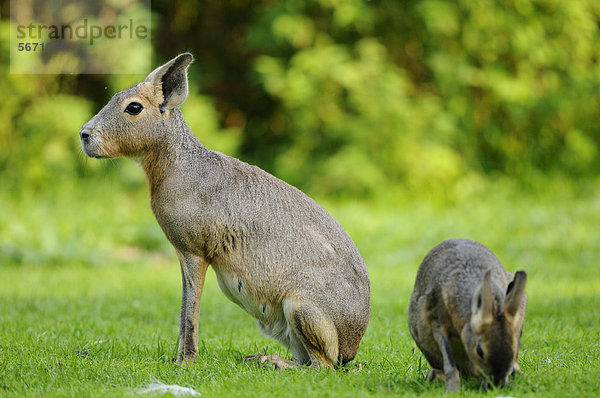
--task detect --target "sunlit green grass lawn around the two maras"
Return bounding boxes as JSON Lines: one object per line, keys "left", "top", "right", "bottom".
{"left": 0, "top": 177, "right": 600, "bottom": 397}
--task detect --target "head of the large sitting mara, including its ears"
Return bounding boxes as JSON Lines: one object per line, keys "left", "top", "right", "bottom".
{"left": 79, "top": 53, "right": 194, "bottom": 158}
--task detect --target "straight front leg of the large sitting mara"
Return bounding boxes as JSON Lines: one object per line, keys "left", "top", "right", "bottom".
{"left": 177, "top": 251, "right": 208, "bottom": 363}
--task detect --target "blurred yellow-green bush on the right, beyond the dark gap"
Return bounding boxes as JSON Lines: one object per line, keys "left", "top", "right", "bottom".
{"left": 243, "top": 0, "right": 600, "bottom": 195}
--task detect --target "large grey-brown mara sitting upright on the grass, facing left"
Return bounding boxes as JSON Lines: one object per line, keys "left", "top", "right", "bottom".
{"left": 80, "top": 54, "right": 370, "bottom": 367}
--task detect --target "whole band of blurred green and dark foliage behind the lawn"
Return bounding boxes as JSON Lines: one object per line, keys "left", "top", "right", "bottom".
{"left": 0, "top": 0, "right": 600, "bottom": 197}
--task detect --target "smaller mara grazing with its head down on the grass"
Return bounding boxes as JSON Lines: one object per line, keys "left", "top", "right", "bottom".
{"left": 408, "top": 239, "right": 527, "bottom": 390}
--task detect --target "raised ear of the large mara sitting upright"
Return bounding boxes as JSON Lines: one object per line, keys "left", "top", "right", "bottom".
{"left": 144, "top": 53, "right": 194, "bottom": 112}
